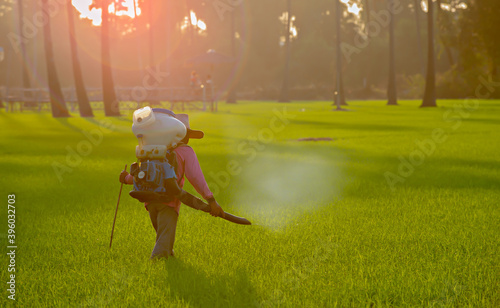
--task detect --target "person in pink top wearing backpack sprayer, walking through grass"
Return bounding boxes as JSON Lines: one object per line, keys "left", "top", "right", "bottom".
{"left": 119, "top": 107, "right": 251, "bottom": 259}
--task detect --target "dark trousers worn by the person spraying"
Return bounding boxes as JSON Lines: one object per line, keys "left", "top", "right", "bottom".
{"left": 148, "top": 203, "right": 179, "bottom": 259}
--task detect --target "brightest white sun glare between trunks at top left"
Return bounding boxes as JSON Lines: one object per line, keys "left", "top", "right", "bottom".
{"left": 71, "top": 0, "right": 141, "bottom": 26}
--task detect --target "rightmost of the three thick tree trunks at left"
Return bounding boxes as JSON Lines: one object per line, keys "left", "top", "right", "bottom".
{"left": 101, "top": 0, "right": 120, "bottom": 117}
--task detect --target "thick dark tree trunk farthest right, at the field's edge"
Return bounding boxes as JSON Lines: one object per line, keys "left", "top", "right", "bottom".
{"left": 420, "top": 0, "right": 437, "bottom": 107}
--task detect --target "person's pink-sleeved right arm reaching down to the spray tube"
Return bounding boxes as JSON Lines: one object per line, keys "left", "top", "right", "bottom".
{"left": 180, "top": 147, "right": 224, "bottom": 217}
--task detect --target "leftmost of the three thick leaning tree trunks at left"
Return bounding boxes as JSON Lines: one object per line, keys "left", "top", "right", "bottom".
{"left": 42, "top": 0, "right": 69, "bottom": 118}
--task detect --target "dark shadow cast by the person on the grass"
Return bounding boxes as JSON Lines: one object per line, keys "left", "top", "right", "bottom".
{"left": 158, "top": 258, "right": 258, "bottom": 307}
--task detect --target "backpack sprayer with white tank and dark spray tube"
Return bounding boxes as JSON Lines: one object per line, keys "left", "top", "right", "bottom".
{"left": 110, "top": 107, "right": 251, "bottom": 246}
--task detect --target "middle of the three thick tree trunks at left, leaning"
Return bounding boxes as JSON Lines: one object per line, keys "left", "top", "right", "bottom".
{"left": 66, "top": 0, "right": 94, "bottom": 117}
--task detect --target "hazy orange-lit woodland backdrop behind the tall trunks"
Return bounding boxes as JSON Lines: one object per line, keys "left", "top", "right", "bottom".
{"left": 0, "top": 0, "right": 500, "bottom": 100}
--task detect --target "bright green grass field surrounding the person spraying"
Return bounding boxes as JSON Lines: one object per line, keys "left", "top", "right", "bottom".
{"left": 0, "top": 100, "right": 500, "bottom": 307}
